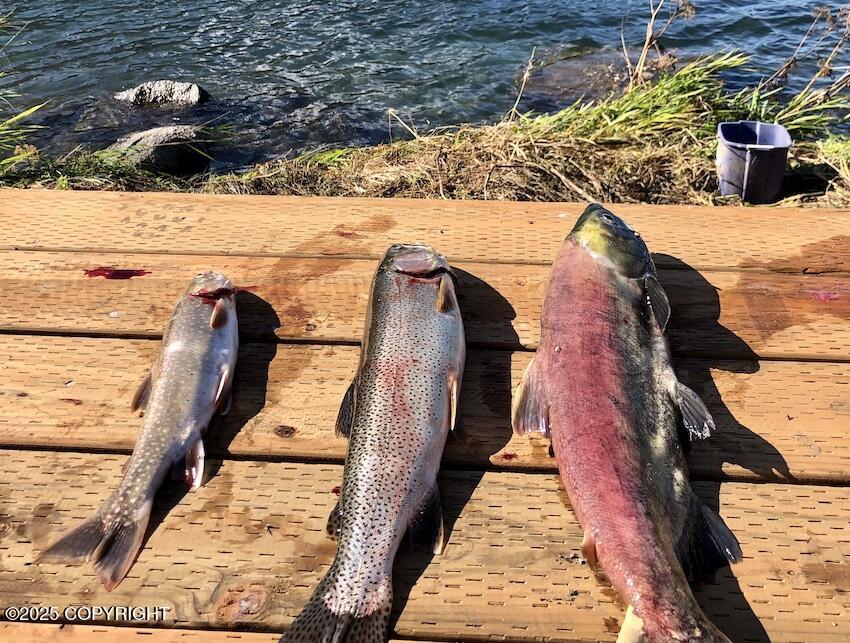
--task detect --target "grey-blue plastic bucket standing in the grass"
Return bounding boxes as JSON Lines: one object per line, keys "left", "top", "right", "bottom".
{"left": 717, "top": 121, "right": 791, "bottom": 203}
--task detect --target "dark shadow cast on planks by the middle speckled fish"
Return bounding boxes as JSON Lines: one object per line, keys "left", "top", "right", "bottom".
{"left": 389, "top": 268, "right": 519, "bottom": 633}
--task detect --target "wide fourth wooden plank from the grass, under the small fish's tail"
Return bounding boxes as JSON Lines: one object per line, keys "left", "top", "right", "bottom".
{"left": 0, "top": 452, "right": 850, "bottom": 641}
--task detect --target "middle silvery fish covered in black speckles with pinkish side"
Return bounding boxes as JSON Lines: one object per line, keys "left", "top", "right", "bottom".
{"left": 281, "top": 245, "right": 466, "bottom": 643}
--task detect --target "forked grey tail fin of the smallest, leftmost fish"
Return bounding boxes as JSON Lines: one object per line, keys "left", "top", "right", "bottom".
{"left": 38, "top": 503, "right": 151, "bottom": 592}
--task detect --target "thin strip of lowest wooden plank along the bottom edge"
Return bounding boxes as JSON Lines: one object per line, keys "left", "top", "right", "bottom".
{"left": 0, "top": 623, "right": 422, "bottom": 643}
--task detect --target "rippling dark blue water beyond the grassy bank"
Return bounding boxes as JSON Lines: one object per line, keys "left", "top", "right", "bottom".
{"left": 0, "top": 0, "right": 836, "bottom": 166}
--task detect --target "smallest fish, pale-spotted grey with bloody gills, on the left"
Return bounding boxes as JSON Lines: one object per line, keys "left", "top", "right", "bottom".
{"left": 39, "top": 272, "right": 239, "bottom": 591}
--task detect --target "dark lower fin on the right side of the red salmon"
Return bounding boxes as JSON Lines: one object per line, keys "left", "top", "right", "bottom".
{"left": 679, "top": 498, "right": 743, "bottom": 581}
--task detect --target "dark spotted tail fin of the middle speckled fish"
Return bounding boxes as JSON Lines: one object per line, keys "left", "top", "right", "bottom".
{"left": 280, "top": 565, "right": 392, "bottom": 643}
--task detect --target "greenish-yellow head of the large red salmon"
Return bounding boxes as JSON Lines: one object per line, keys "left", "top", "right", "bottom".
{"left": 567, "top": 203, "right": 655, "bottom": 278}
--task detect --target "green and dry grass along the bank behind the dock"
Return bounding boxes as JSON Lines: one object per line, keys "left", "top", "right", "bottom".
{"left": 0, "top": 0, "right": 850, "bottom": 207}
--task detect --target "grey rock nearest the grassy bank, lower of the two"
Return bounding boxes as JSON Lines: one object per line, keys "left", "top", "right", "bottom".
{"left": 108, "top": 125, "right": 209, "bottom": 175}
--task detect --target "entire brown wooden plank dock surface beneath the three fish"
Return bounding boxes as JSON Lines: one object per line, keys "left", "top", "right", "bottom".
{"left": 0, "top": 190, "right": 850, "bottom": 643}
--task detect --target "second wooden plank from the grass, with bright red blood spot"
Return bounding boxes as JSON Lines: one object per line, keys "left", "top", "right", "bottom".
{"left": 0, "top": 252, "right": 850, "bottom": 361}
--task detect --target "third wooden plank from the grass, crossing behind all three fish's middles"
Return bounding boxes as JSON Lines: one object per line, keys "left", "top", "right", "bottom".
{"left": 0, "top": 336, "right": 850, "bottom": 484}
